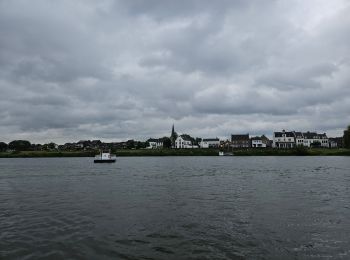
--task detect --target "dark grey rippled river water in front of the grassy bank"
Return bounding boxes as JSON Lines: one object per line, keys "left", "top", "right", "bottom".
{"left": 0, "top": 156, "right": 350, "bottom": 259}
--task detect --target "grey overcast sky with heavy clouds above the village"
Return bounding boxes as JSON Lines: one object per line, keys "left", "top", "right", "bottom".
{"left": 0, "top": 0, "right": 350, "bottom": 143}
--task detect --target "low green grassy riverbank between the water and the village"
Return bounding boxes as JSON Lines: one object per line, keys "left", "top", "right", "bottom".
{"left": 0, "top": 148, "right": 350, "bottom": 158}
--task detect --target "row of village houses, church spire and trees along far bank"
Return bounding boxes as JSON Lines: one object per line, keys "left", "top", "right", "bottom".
{"left": 0, "top": 125, "right": 350, "bottom": 152}
